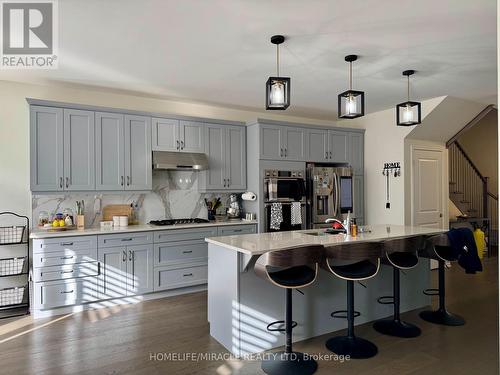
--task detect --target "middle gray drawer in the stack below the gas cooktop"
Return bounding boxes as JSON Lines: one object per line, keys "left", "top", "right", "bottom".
{"left": 155, "top": 240, "right": 208, "bottom": 265}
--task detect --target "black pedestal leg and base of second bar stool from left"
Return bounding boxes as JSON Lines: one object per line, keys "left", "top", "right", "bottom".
{"left": 325, "top": 280, "right": 378, "bottom": 359}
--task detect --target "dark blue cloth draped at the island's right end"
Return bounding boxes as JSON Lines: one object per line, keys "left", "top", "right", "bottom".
{"left": 448, "top": 228, "right": 483, "bottom": 273}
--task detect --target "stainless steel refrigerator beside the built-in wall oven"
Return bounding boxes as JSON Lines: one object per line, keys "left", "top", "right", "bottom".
{"left": 306, "top": 163, "right": 354, "bottom": 229}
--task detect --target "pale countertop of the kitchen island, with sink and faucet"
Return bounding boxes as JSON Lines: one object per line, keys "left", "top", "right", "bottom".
{"left": 206, "top": 225, "right": 447, "bottom": 255}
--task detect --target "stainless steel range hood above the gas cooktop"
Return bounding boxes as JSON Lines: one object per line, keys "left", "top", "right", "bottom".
{"left": 153, "top": 151, "right": 208, "bottom": 171}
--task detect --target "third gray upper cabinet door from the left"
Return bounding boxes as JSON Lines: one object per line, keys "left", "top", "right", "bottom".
{"left": 95, "top": 112, "right": 125, "bottom": 190}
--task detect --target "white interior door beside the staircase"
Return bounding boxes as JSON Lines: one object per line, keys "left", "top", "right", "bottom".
{"left": 412, "top": 149, "right": 444, "bottom": 228}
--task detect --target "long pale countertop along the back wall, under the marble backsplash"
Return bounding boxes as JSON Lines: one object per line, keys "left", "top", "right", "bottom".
{"left": 30, "top": 220, "right": 257, "bottom": 239}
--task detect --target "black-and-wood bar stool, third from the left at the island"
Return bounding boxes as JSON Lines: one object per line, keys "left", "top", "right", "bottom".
{"left": 373, "top": 236, "right": 425, "bottom": 338}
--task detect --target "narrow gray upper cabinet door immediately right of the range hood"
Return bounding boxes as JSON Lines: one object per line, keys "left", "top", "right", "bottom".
{"left": 202, "top": 124, "right": 226, "bottom": 190}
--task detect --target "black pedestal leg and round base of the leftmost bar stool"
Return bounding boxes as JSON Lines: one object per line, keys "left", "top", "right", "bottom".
{"left": 261, "top": 288, "right": 318, "bottom": 375}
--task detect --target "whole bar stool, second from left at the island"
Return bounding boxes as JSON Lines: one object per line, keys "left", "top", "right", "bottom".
{"left": 322, "top": 242, "right": 381, "bottom": 358}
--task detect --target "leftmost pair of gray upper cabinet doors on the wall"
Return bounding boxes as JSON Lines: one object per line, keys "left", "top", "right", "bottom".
{"left": 30, "top": 106, "right": 95, "bottom": 191}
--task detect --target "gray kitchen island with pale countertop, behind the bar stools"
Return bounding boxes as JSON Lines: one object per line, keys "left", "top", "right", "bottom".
{"left": 206, "top": 225, "right": 445, "bottom": 356}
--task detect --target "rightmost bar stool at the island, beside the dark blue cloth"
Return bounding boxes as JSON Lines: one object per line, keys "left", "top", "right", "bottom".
{"left": 419, "top": 233, "right": 465, "bottom": 326}
